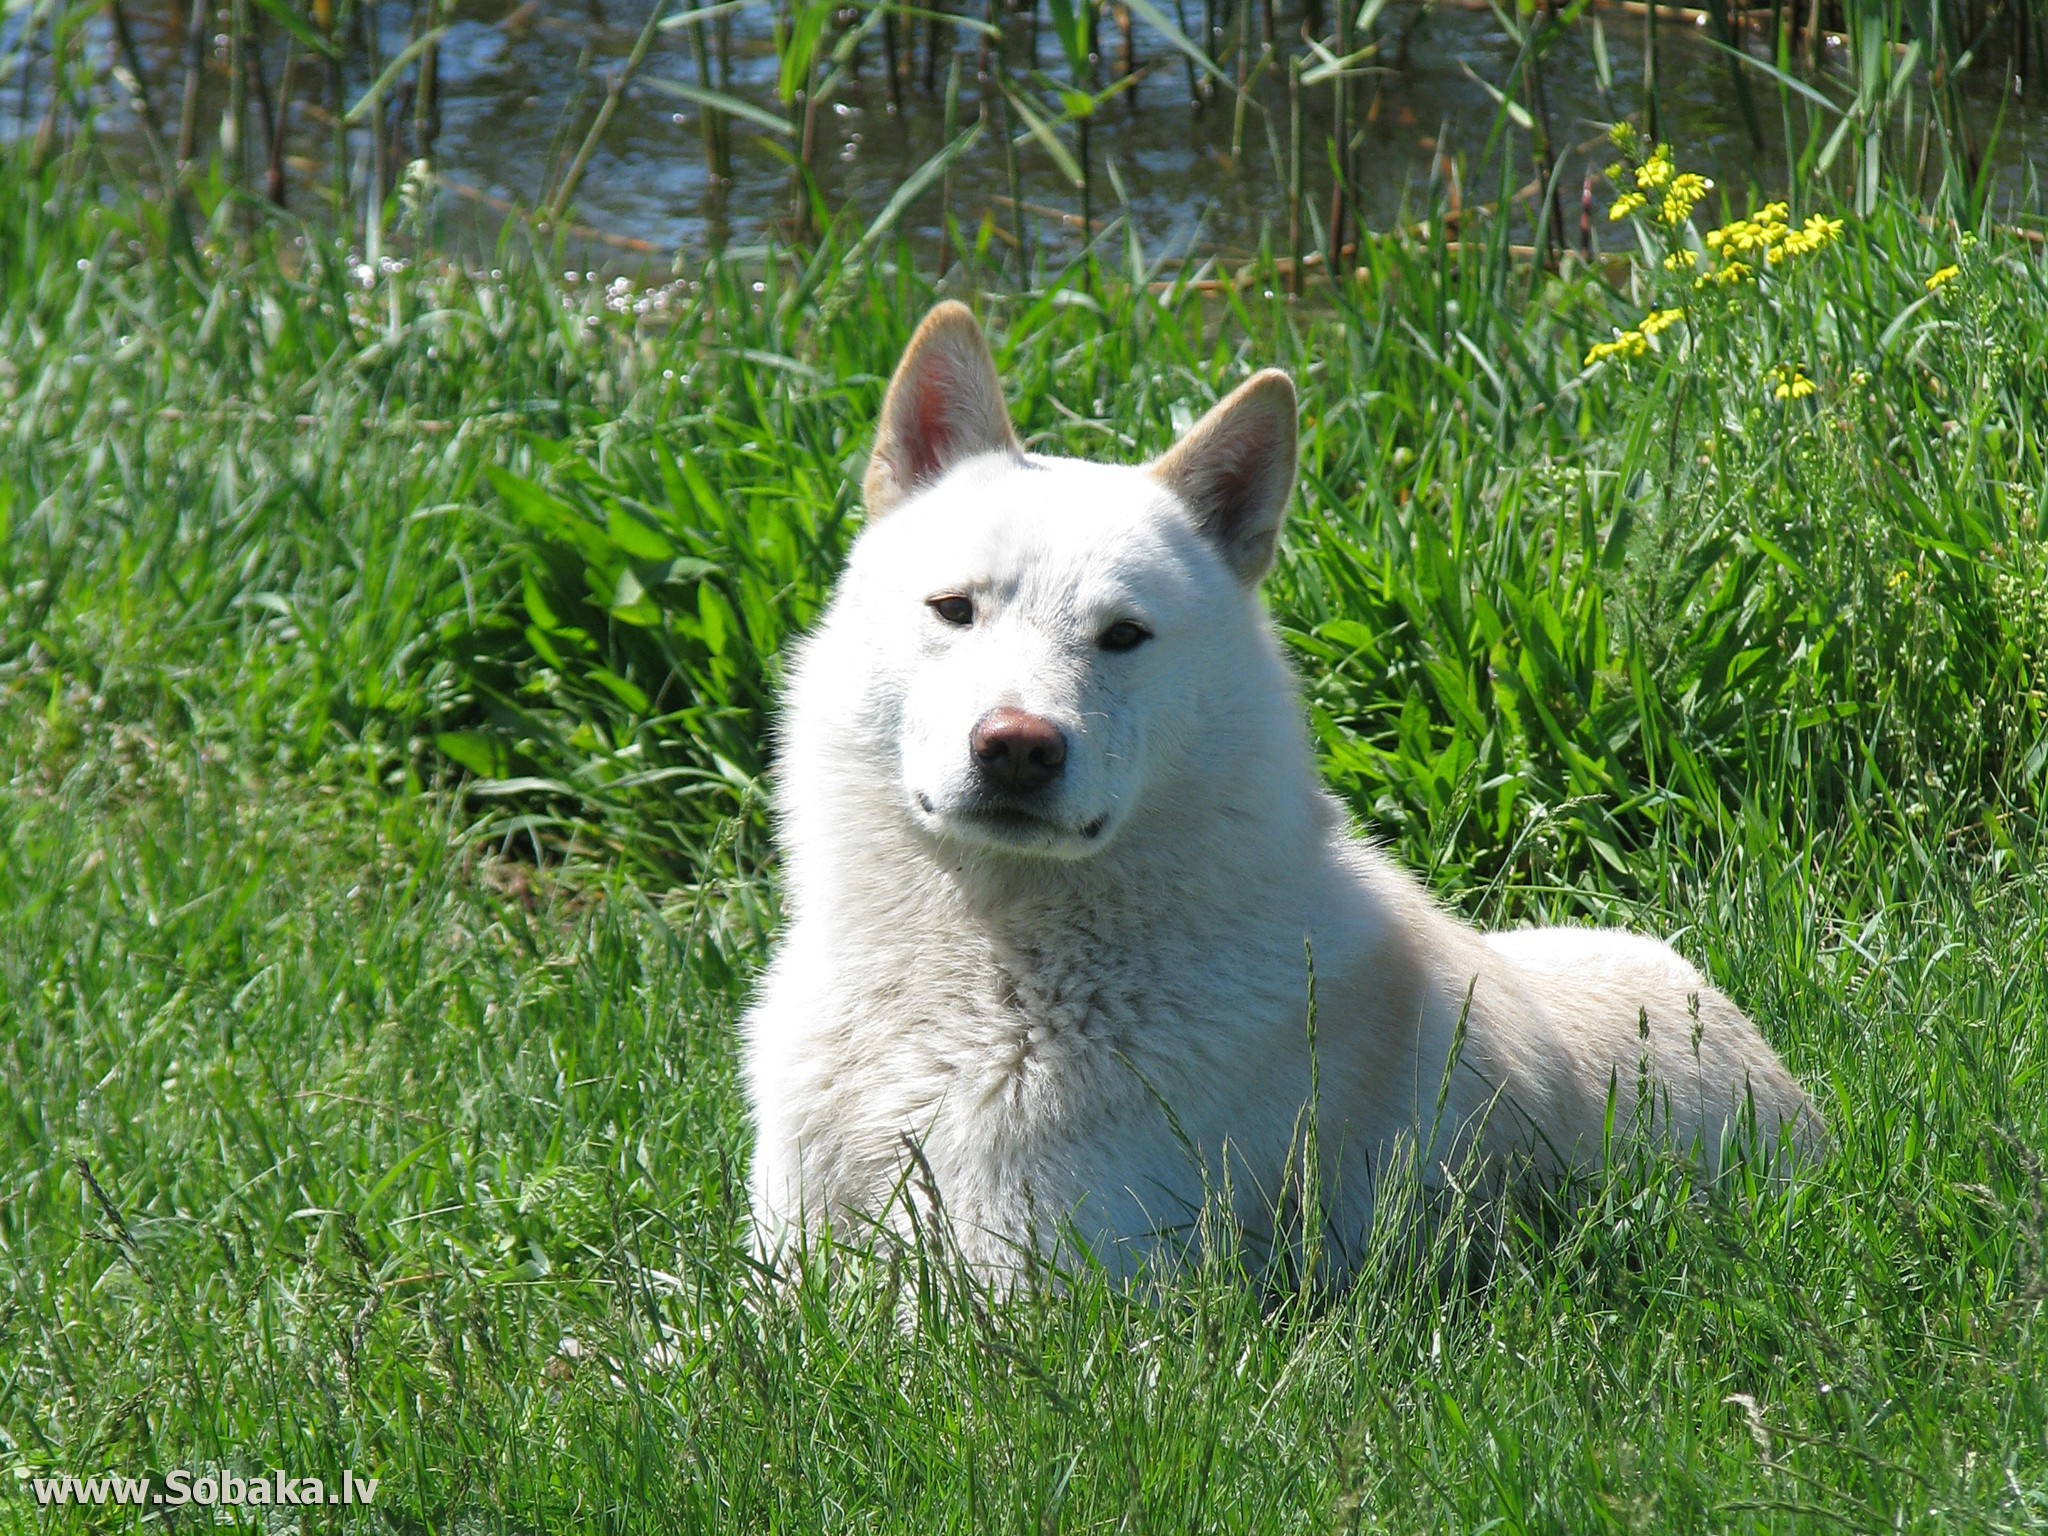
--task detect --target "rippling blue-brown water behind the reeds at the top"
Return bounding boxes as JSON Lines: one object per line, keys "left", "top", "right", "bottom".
{"left": 0, "top": 0, "right": 2042, "bottom": 262}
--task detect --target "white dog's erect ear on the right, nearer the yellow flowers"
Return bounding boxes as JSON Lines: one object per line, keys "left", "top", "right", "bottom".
{"left": 1151, "top": 369, "right": 1294, "bottom": 586}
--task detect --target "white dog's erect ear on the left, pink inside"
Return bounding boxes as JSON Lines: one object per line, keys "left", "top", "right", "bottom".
{"left": 862, "top": 299, "right": 1024, "bottom": 520}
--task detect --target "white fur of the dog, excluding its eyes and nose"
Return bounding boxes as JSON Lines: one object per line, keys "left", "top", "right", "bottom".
{"left": 745, "top": 305, "right": 1825, "bottom": 1280}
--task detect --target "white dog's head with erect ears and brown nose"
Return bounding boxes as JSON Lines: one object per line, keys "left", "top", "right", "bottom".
{"left": 815, "top": 303, "right": 1294, "bottom": 858}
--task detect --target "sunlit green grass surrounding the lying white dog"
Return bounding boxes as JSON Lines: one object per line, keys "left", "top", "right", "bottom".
{"left": 0, "top": 141, "right": 2048, "bottom": 1532}
